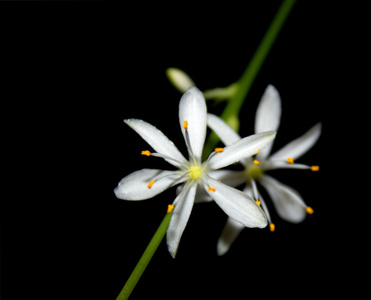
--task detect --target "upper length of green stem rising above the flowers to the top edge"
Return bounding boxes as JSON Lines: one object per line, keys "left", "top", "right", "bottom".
{"left": 204, "top": 0, "right": 295, "bottom": 159}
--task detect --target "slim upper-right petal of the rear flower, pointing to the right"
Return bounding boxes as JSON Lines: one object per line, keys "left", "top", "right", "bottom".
{"left": 270, "top": 123, "right": 322, "bottom": 160}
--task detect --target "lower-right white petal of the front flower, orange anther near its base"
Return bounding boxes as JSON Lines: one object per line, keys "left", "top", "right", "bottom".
{"left": 203, "top": 177, "right": 267, "bottom": 228}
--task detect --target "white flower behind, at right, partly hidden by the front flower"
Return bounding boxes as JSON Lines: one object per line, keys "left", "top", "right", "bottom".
{"left": 207, "top": 85, "right": 321, "bottom": 255}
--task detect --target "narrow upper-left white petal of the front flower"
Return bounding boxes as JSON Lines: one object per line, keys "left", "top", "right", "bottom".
{"left": 124, "top": 119, "right": 188, "bottom": 168}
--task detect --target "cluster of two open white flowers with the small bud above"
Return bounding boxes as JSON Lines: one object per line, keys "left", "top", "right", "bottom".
{"left": 114, "top": 69, "right": 321, "bottom": 257}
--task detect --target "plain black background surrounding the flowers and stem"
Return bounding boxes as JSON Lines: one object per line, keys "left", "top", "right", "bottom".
{"left": 1, "top": 1, "right": 364, "bottom": 299}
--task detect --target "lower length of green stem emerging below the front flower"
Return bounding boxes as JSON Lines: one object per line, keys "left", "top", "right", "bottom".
{"left": 116, "top": 212, "right": 172, "bottom": 300}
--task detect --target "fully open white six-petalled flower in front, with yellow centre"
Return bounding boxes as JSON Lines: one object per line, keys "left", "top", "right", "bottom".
{"left": 114, "top": 87, "right": 276, "bottom": 257}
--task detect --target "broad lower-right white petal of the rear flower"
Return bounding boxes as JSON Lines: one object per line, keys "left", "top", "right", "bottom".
{"left": 259, "top": 174, "right": 307, "bottom": 223}
